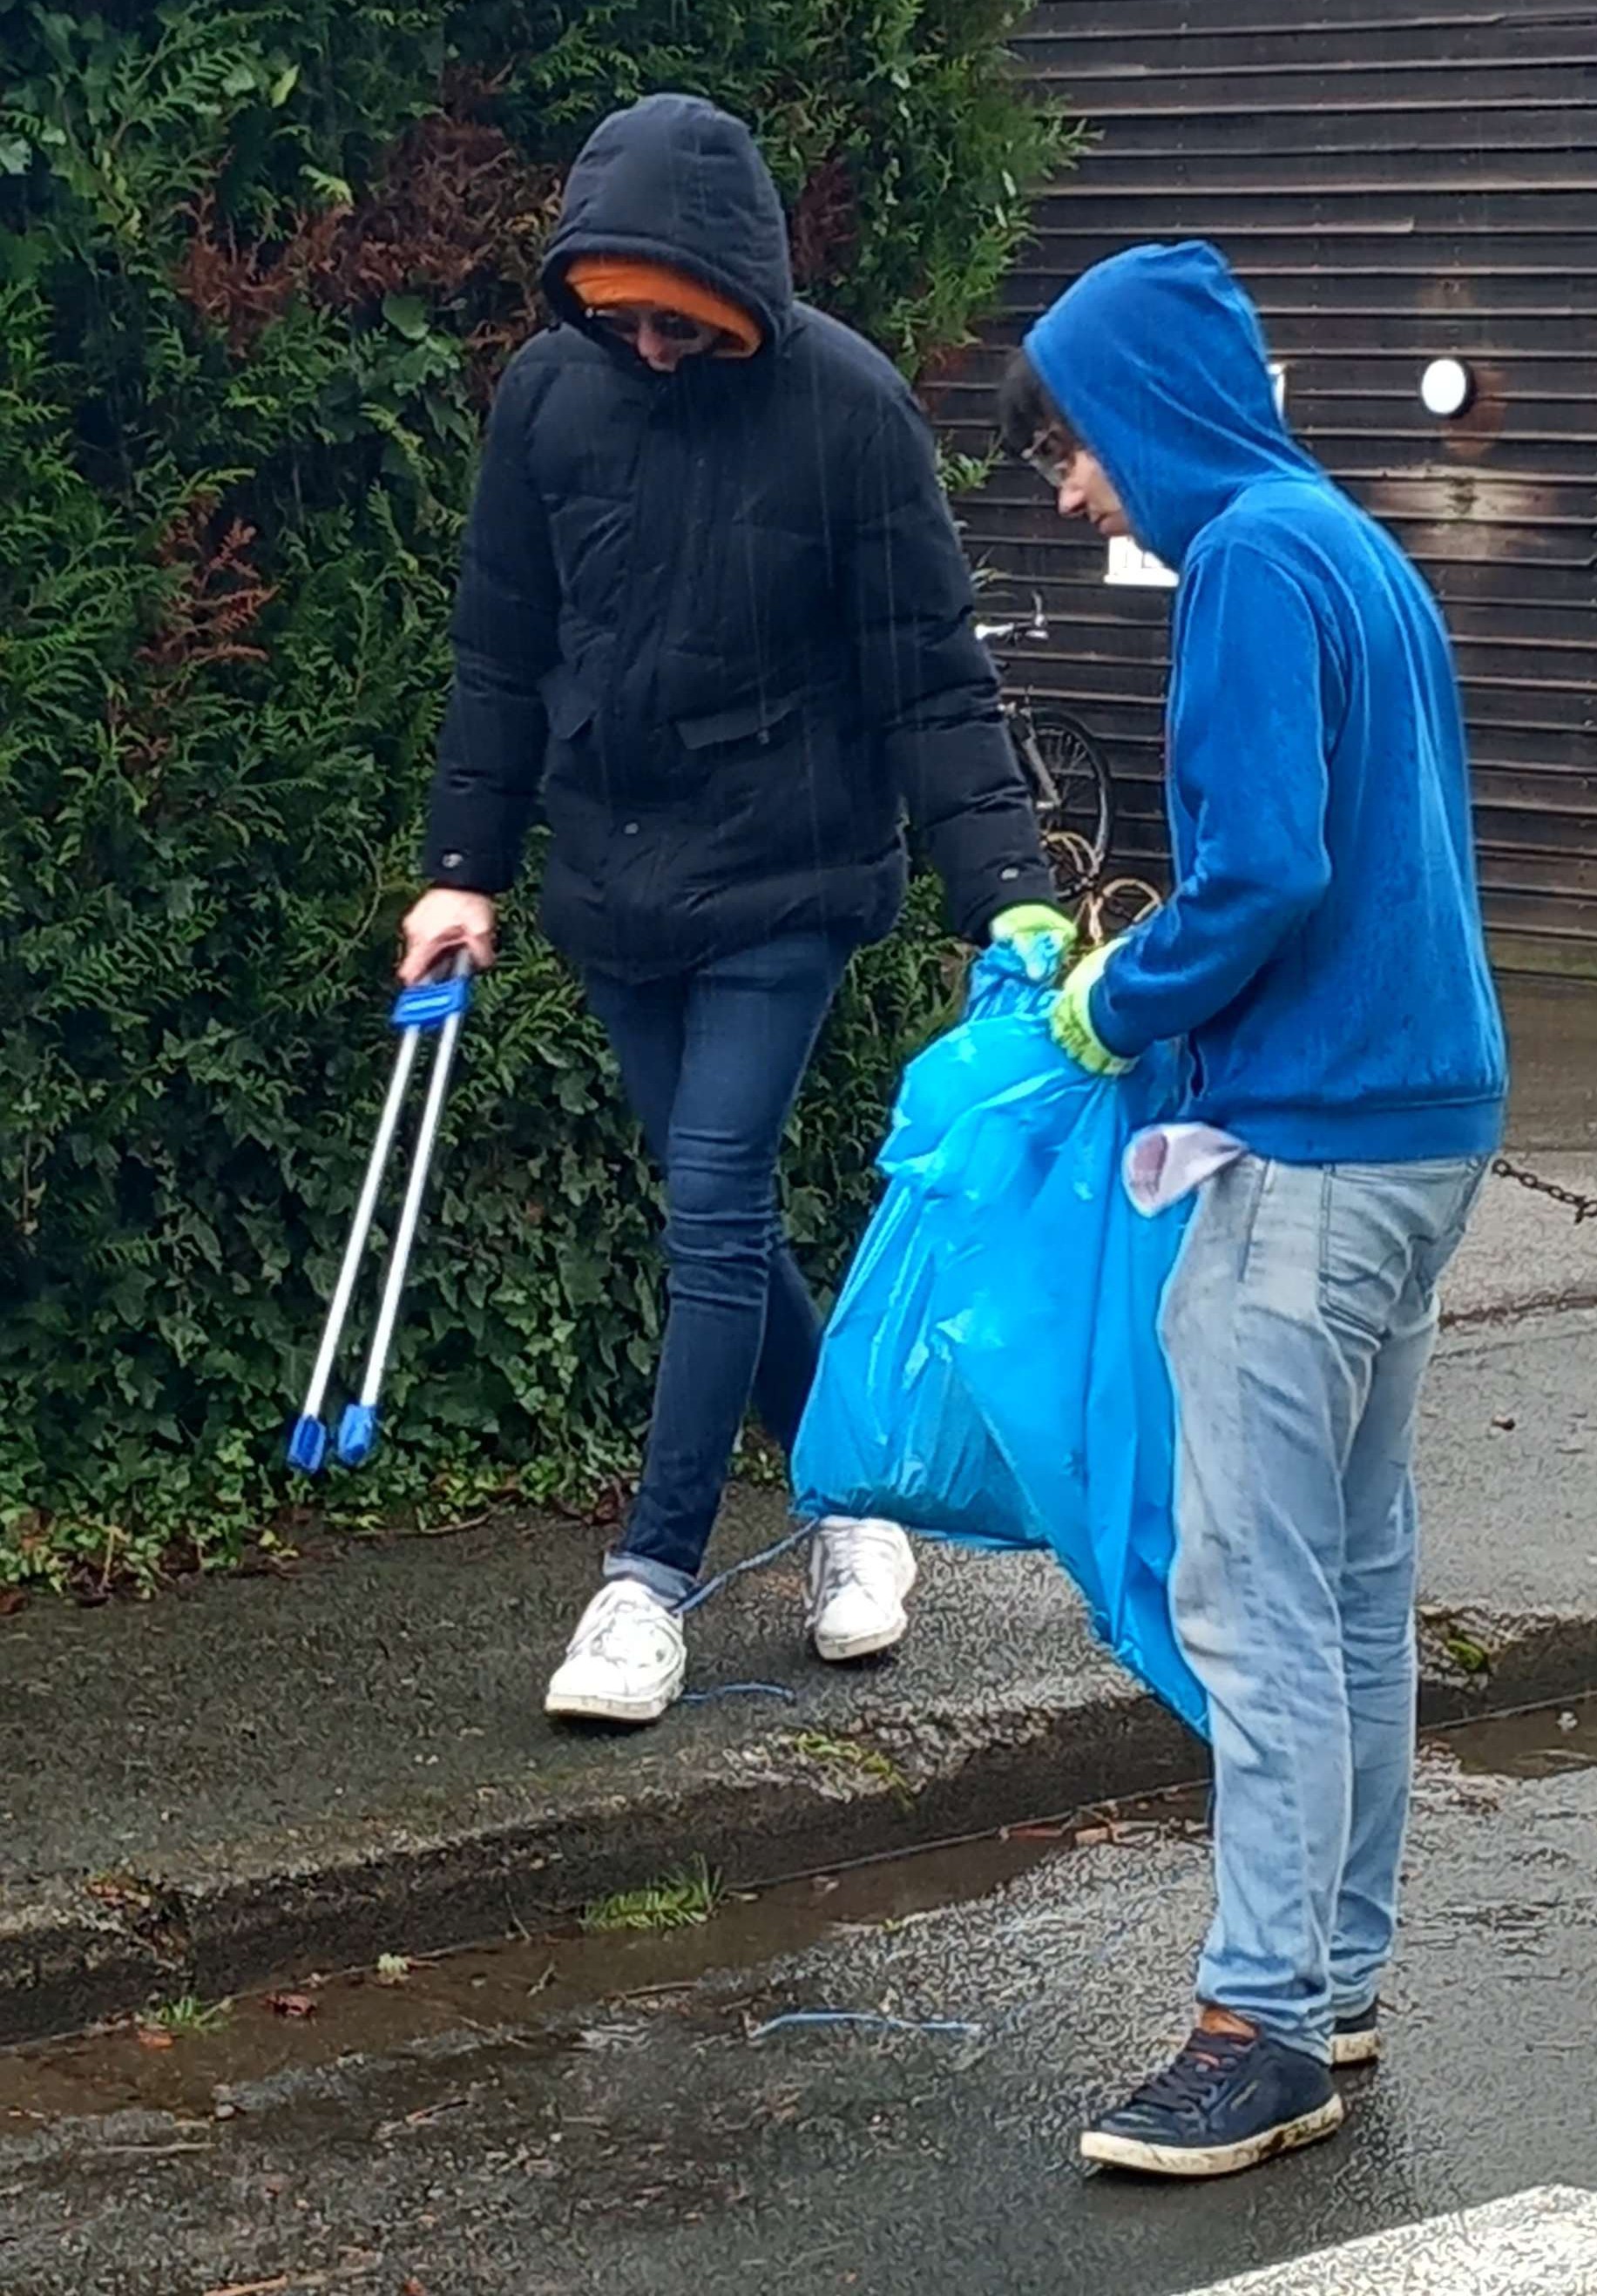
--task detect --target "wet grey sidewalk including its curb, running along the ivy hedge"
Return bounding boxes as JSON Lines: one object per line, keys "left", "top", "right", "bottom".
{"left": 0, "top": 992, "right": 1597, "bottom": 2039}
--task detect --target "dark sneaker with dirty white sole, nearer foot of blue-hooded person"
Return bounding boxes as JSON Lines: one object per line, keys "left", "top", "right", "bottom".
{"left": 1082, "top": 2032, "right": 1342, "bottom": 2177}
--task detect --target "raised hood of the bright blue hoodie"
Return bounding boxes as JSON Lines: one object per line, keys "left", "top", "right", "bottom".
{"left": 1025, "top": 239, "right": 1323, "bottom": 567}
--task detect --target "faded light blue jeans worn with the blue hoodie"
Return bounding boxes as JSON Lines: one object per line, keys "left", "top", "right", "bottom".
{"left": 1163, "top": 1158, "right": 1486, "bottom": 2059}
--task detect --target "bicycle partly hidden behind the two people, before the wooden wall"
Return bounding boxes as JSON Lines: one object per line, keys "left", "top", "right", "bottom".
{"left": 977, "top": 595, "right": 1158, "bottom": 946}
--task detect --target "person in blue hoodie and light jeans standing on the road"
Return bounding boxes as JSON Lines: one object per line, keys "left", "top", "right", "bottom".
{"left": 1002, "top": 243, "right": 1506, "bottom": 2177}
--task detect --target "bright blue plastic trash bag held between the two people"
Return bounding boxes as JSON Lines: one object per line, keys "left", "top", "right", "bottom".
{"left": 793, "top": 949, "right": 1207, "bottom": 1733}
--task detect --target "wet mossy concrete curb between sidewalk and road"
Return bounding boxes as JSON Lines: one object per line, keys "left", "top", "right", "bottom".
{"left": 0, "top": 1607, "right": 1597, "bottom": 2043}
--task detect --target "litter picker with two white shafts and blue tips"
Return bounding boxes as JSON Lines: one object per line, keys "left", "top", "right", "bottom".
{"left": 288, "top": 949, "right": 471, "bottom": 1474}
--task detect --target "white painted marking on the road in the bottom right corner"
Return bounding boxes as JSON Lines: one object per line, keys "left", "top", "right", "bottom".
{"left": 1204, "top": 2185, "right": 1597, "bottom": 2296}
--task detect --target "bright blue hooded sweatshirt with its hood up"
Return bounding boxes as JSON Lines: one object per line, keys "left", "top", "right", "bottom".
{"left": 1025, "top": 243, "right": 1506, "bottom": 1164}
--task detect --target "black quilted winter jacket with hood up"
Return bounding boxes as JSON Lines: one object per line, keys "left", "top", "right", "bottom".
{"left": 425, "top": 97, "right": 1052, "bottom": 978}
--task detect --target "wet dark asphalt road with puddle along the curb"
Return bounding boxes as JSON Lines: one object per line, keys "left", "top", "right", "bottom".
{"left": 0, "top": 1708, "right": 1597, "bottom": 2296}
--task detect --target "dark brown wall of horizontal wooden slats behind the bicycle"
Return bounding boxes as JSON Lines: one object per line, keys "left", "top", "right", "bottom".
{"left": 930, "top": 0, "right": 1597, "bottom": 974}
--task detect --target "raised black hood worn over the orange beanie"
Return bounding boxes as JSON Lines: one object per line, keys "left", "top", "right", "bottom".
{"left": 542, "top": 97, "right": 793, "bottom": 344}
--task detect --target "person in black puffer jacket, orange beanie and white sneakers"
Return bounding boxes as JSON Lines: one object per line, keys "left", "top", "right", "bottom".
{"left": 403, "top": 97, "right": 1071, "bottom": 1722}
